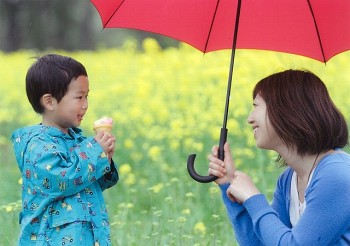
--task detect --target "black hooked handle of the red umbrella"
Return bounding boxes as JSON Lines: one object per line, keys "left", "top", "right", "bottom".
{"left": 187, "top": 128, "right": 227, "bottom": 183}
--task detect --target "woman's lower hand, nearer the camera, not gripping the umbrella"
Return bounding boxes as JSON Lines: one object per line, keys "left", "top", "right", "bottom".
{"left": 226, "top": 171, "right": 260, "bottom": 203}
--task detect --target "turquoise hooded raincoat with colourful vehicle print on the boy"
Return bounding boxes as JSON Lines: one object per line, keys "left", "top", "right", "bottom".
{"left": 11, "top": 125, "right": 119, "bottom": 245}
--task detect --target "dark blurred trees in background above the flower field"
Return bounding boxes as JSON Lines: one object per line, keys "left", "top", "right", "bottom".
{"left": 0, "top": 0, "right": 178, "bottom": 52}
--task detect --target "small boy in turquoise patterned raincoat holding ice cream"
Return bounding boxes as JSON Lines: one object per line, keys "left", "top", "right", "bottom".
{"left": 11, "top": 54, "right": 119, "bottom": 245}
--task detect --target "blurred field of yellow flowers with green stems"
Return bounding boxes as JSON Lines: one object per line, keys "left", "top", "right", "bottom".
{"left": 0, "top": 39, "right": 350, "bottom": 245}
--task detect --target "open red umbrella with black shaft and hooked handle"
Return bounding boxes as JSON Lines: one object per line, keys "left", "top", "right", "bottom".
{"left": 91, "top": 0, "right": 350, "bottom": 183}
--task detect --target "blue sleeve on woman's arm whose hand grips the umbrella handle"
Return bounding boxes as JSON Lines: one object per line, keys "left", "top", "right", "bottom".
{"left": 219, "top": 184, "right": 263, "bottom": 246}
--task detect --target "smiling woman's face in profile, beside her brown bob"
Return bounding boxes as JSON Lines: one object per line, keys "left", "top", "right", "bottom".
{"left": 247, "top": 94, "right": 283, "bottom": 150}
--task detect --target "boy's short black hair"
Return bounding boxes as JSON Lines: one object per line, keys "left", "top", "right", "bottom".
{"left": 26, "top": 54, "right": 88, "bottom": 114}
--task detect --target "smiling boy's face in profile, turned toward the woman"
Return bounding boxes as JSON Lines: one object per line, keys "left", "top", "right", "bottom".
{"left": 51, "top": 76, "right": 89, "bottom": 133}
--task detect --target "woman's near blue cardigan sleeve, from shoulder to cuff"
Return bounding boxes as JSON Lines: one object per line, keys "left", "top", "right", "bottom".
{"left": 243, "top": 157, "right": 350, "bottom": 246}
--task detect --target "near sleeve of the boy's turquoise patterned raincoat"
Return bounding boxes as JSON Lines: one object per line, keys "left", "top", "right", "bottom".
{"left": 24, "top": 137, "right": 111, "bottom": 199}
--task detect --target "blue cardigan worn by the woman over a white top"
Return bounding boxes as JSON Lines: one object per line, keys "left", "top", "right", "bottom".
{"left": 220, "top": 151, "right": 350, "bottom": 246}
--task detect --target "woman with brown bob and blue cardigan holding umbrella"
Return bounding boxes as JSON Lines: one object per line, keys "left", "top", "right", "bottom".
{"left": 208, "top": 70, "right": 350, "bottom": 246}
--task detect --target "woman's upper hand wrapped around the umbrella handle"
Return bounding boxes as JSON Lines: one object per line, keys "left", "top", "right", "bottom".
{"left": 208, "top": 143, "right": 236, "bottom": 184}
